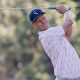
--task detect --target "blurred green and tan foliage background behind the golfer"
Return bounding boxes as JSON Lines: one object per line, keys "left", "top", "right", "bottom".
{"left": 0, "top": 0, "right": 80, "bottom": 80}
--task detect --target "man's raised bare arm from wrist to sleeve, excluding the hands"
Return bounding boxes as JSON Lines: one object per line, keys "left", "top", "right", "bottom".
{"left": 62, "top": 11, "right": 73, "bottom": 41}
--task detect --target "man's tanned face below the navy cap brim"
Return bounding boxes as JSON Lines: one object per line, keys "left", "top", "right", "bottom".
{"left": 32, "top": 14, "right": 49, "bottom": 31}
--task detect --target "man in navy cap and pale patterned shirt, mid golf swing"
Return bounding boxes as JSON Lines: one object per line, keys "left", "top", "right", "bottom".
{"left": 29, "top": 5, "right": 80, "bottom": 80}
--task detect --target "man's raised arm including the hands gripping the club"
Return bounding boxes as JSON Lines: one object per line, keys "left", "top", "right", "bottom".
{"left": 57, "top": 5, "right": 73, "bottom": 40}
